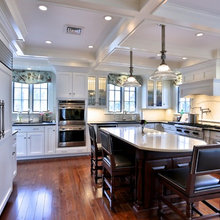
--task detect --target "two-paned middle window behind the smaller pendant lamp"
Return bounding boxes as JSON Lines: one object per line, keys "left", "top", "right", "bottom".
{"left": 108, "top": 84, "right": 136, "bottom": 112}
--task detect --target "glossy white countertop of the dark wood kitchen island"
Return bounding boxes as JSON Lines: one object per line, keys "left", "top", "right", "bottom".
{"left": 101, "top": 127, "right": 207, "bottom": 152}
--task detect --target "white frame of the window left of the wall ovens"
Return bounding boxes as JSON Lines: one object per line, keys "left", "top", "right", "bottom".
{"left": 12, "top": 82, "right": 49, "bottom": 113}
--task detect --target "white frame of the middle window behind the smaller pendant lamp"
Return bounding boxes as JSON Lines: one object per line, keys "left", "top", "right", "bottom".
{"left": 107, "top": 84, "right": 138, "bottom": 114}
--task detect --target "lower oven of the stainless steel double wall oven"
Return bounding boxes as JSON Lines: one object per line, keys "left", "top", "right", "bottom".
{"left": 59, "top": 125, "right": 86, "bottom": 147}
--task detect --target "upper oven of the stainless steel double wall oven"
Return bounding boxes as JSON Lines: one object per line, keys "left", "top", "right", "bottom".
{"left": 58, "top": 100, "right": 85, "bottom": 125}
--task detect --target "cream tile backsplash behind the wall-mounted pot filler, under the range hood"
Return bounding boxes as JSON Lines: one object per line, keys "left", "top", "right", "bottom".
{"left": 191, "top": 95, "right": 220, "bottom": 121}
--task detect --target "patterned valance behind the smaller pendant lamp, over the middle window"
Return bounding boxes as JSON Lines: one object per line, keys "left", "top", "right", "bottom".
{"left": 108, "top": 73, "right": 143, "bottom": 87}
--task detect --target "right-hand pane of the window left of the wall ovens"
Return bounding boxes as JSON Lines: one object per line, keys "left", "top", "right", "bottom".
{"left": 32, "top": 83, "right": 48, "bottom": 112}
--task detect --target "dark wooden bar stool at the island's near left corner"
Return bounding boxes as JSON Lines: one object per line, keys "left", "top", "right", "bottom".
{"left": 100, "top": 131, "right": 134, "bottom": 209}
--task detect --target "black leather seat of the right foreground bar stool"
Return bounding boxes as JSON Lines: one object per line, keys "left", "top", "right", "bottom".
{"left": 159, "top": 167, "right": 220, "bottom": 191}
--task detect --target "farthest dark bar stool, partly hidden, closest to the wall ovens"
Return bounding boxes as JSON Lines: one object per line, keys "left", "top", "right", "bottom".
{"left": 88, "top": 124, "right": 102, "bottom": 184}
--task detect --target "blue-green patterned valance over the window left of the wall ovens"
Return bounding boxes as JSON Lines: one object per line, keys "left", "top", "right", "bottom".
{"left": 12, "top": 70, "right": 53, "bottom": 84}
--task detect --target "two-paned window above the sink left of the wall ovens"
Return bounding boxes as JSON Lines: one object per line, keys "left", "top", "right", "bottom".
{"left": 13, "top": 82, "right": 48, "bottom": 112}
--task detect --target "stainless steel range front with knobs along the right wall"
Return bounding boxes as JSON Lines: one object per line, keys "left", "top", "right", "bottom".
{"left": 175, "top": 124, "right": 203, "bottom": 139}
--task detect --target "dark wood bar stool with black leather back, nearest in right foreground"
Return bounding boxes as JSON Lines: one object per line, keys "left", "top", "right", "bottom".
{"left": 158, "top": 144, "right": 220, "bottom": 219}
